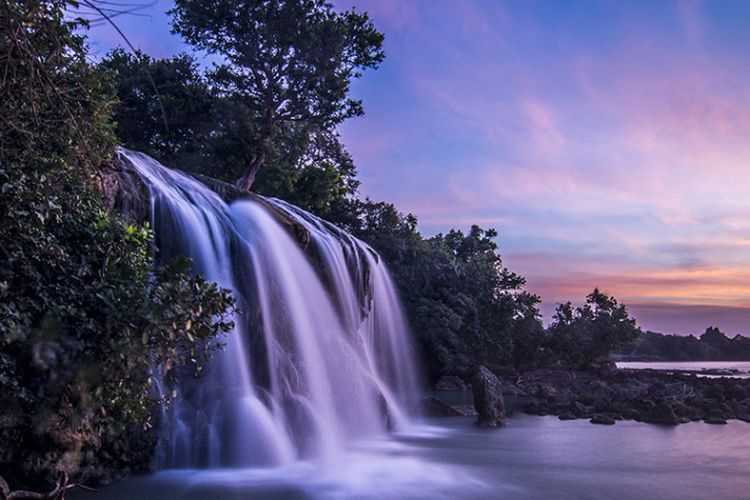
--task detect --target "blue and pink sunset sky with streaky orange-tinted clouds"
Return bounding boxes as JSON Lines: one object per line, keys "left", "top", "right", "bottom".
{"left": 85, "top": 0, "right": 750, "bottom": 335}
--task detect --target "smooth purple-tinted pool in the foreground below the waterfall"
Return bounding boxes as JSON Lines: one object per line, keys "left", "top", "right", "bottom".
{"left": 73, "top": 415, "right": 750, "bottom": 500}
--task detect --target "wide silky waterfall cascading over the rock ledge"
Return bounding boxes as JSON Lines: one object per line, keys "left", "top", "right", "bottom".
{"left": 121, "top": 150, "right": 417, "bottom": 468}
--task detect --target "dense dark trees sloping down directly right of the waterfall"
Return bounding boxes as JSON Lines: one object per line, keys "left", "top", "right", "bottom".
{"left": 349, "top": 202, "right": 543, "bottom": 379}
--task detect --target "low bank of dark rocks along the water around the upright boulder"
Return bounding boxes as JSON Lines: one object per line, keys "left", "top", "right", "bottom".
{"left": 426, "top": 367, "right": 750, "bottom": 425}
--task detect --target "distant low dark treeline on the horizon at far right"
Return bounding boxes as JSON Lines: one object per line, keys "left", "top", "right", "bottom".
{"left": 616, "top": 327, "right": 750, "bottom": 361}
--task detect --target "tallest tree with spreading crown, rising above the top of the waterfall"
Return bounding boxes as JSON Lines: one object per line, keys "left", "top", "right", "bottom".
{"left": 170, "top": 0, "right": 384, "bottom": 189}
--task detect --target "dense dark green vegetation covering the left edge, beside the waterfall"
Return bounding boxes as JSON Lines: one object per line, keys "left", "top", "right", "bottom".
{"left": 0, "top": 1, "right": 232, "bottom": 492}
